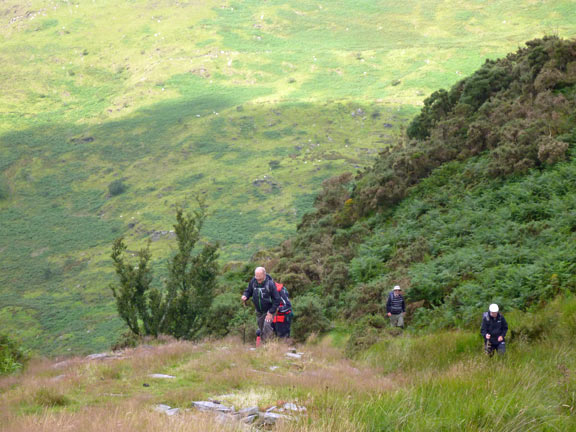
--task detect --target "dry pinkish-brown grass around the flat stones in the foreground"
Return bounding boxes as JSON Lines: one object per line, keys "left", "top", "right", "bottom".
{"left": 0, "top": 339, "right": 397, "bottom": 432}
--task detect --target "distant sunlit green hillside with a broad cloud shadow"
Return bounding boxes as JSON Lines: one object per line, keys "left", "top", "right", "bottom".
{"left": 0, "top": 0, "right": 574, "bottom": 353}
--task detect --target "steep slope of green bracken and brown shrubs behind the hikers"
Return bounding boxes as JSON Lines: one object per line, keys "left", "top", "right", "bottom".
{"left": 269, "top": 37, "right": 576, "bottom": 334}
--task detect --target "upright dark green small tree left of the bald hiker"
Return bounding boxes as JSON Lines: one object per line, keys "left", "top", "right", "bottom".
{"left": 111, "top": 201, "right": 218, "bottom": 339}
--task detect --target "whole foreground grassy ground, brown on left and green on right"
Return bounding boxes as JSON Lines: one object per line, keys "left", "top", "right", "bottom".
{"left": 0, "top": 295, "right": 576, "bottom": 432}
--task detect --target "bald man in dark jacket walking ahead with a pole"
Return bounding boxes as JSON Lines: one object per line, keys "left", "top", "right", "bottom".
{"left": 242, "top": 267, "right": 280, "bottom": 342}
